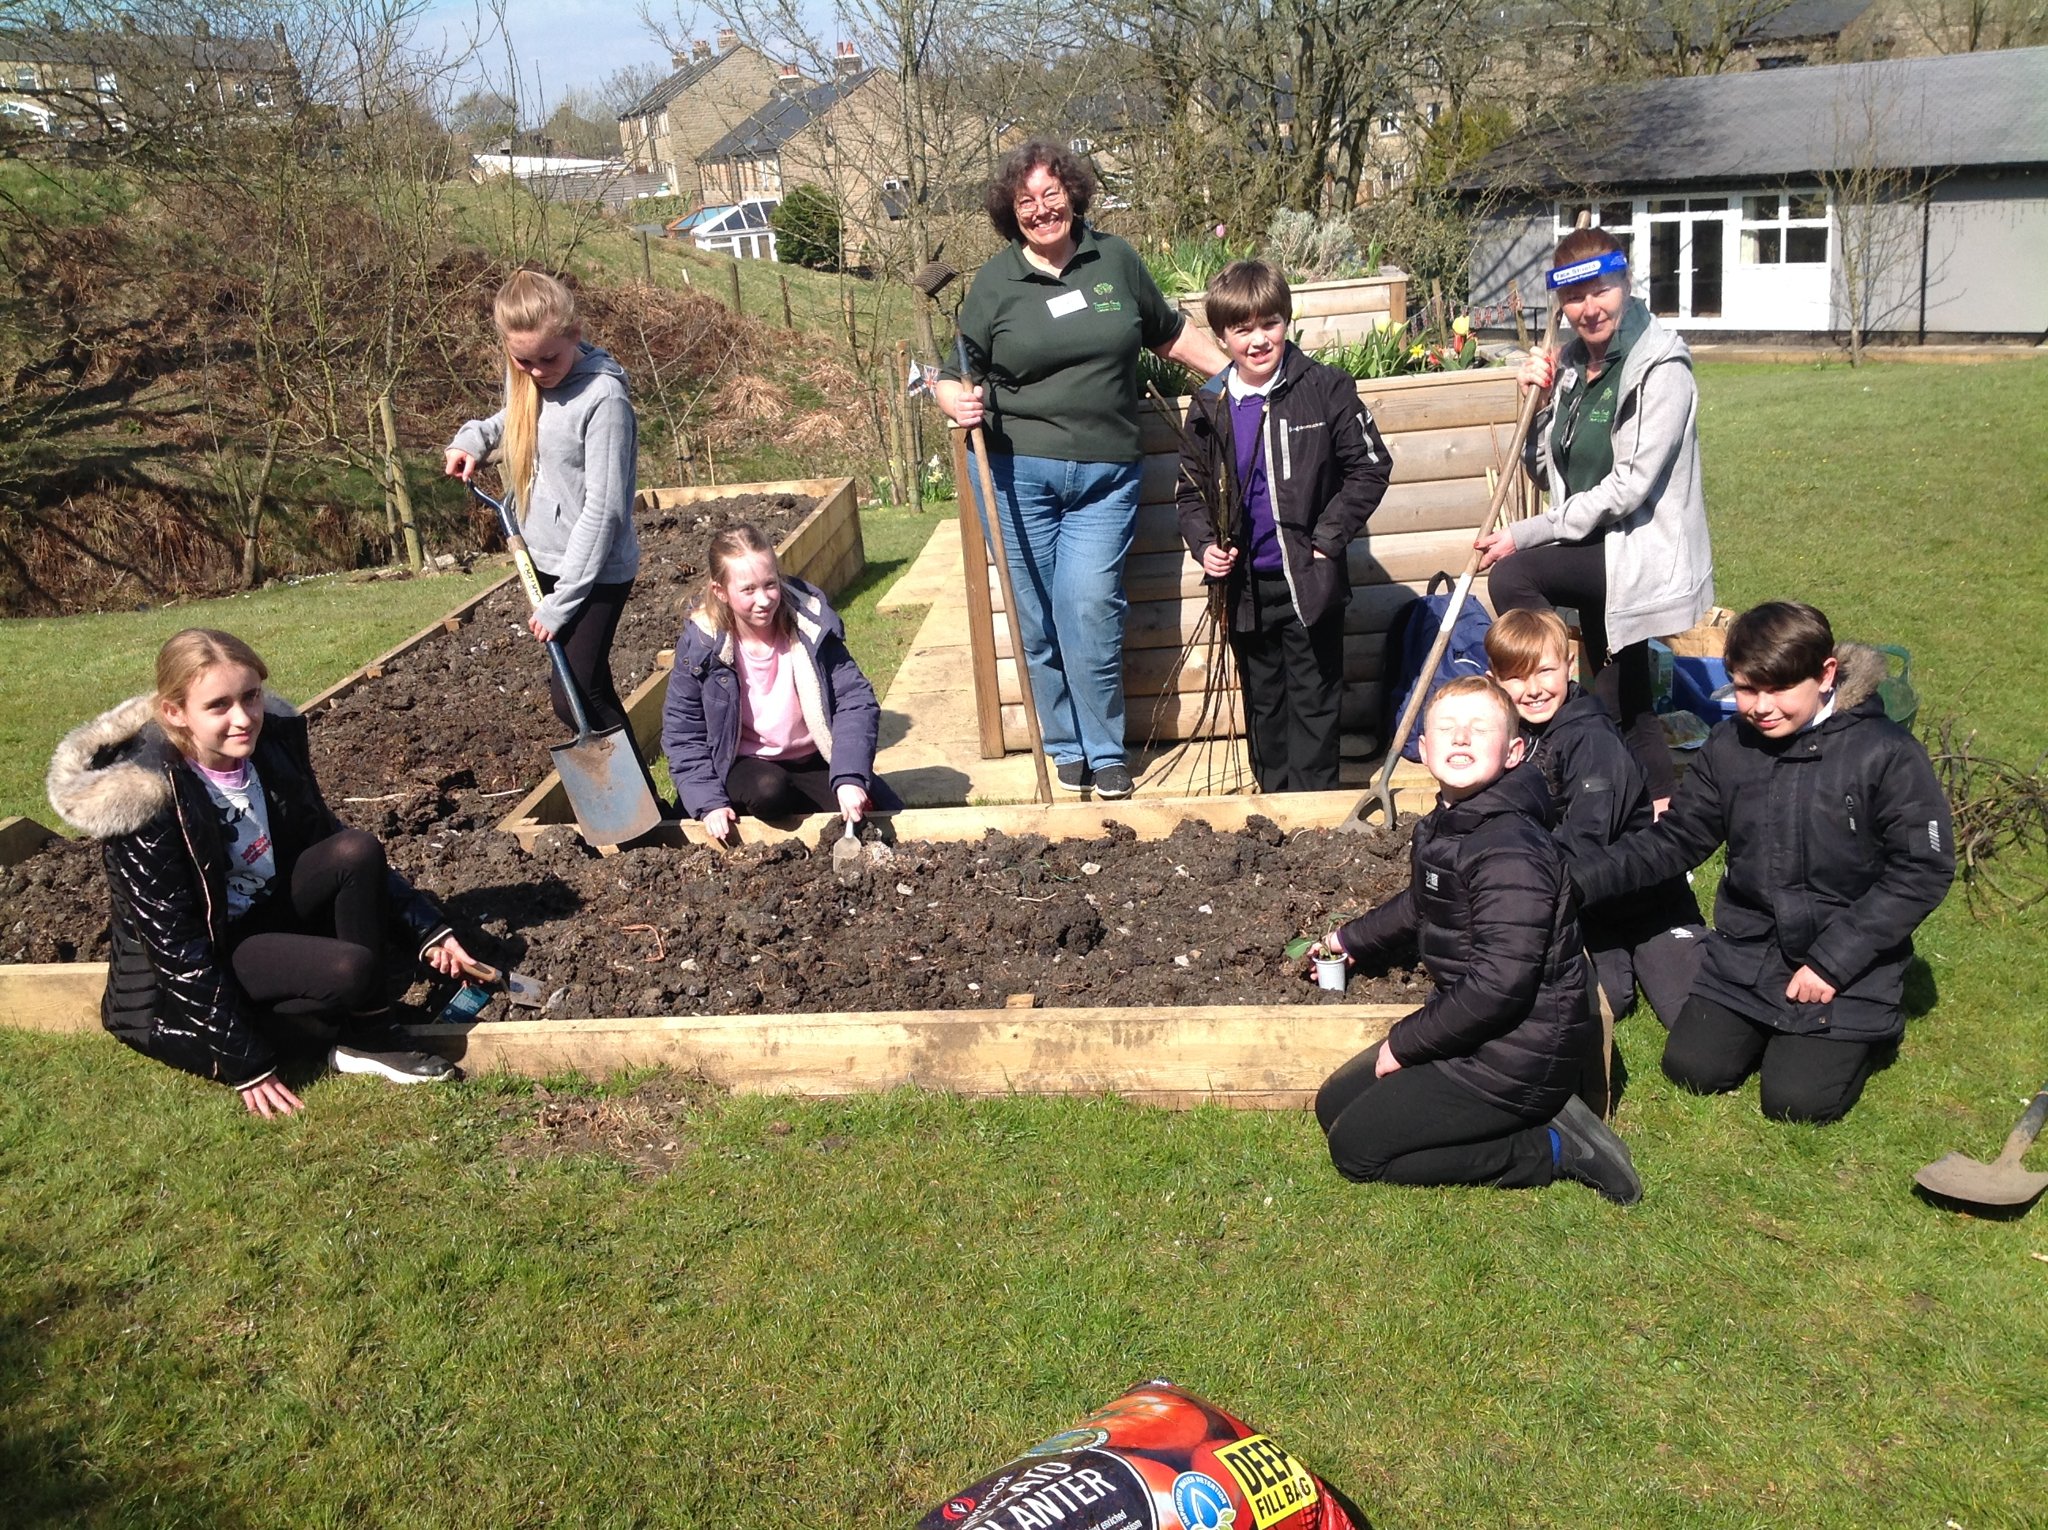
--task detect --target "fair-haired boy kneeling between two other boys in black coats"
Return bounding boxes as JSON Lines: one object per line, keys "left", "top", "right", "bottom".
{"left": 1487, "top": 610, "right": 1706, "bottom": 1030}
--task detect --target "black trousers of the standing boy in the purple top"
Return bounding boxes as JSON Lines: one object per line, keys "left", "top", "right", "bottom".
{"left": 1231, "top": 571, "right": 1343, "bottom": 791}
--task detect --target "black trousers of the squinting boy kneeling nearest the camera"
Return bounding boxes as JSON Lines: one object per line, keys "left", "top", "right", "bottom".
{"left": 1315, "top": 1043, "right": 1554, "bottom": 1190}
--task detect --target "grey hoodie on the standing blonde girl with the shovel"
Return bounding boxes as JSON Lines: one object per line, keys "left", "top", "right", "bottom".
{"left": 451, "top": 344, "right": 639, "bottom": 633}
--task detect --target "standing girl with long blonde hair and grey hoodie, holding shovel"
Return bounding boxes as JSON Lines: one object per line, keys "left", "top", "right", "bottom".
{"left": 442, "top": 270, "right": 639, "bottom": 731}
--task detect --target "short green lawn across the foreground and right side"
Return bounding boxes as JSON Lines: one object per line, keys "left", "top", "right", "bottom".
{"left": 0, "top": 365, "right": 2048, "bottom": 1530}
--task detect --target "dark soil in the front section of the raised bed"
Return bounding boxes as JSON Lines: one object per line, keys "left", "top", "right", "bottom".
{"left": 0, "top": 817, "right": 1425, "bottom": 1018}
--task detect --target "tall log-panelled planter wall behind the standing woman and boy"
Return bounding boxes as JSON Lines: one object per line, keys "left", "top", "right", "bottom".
{"left": 952, "top": 367, "right": 1520, "bottom": 760}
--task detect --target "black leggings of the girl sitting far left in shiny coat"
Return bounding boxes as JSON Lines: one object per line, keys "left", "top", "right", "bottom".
{"left": 227, "top": 830, "right": 389, "bottom": 1016}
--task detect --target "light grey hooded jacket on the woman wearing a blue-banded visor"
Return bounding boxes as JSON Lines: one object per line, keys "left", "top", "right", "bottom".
{"left": 1507, "top": 297, "right": 1714, "bottom": 649}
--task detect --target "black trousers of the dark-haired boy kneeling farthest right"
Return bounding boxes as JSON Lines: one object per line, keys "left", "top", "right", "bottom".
{"left": 1663, "top": 993, "right": 1878, "bottom": 1124}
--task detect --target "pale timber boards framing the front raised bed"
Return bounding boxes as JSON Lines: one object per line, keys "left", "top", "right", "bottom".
{"left": 0, "top": 793, "right": 1409, "bottom": 1108}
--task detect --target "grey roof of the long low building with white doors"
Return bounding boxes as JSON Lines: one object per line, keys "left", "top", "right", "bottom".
{"left": 1458, "top": 47, "right": 2048, "bottom": 190}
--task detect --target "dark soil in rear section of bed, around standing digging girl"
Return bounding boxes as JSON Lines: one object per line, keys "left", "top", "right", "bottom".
{"left": 313, "top": 494, "right": 815, "bottom": 840}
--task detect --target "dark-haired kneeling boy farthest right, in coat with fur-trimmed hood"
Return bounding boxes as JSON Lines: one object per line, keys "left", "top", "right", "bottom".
{"left": 1571, "top": 600, "right": 1956, "bottom": 1122}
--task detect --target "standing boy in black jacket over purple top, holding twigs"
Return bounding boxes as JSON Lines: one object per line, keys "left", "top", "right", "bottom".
{"left": 1178, "top": 260, "right": 1391, "bottom": 791}
